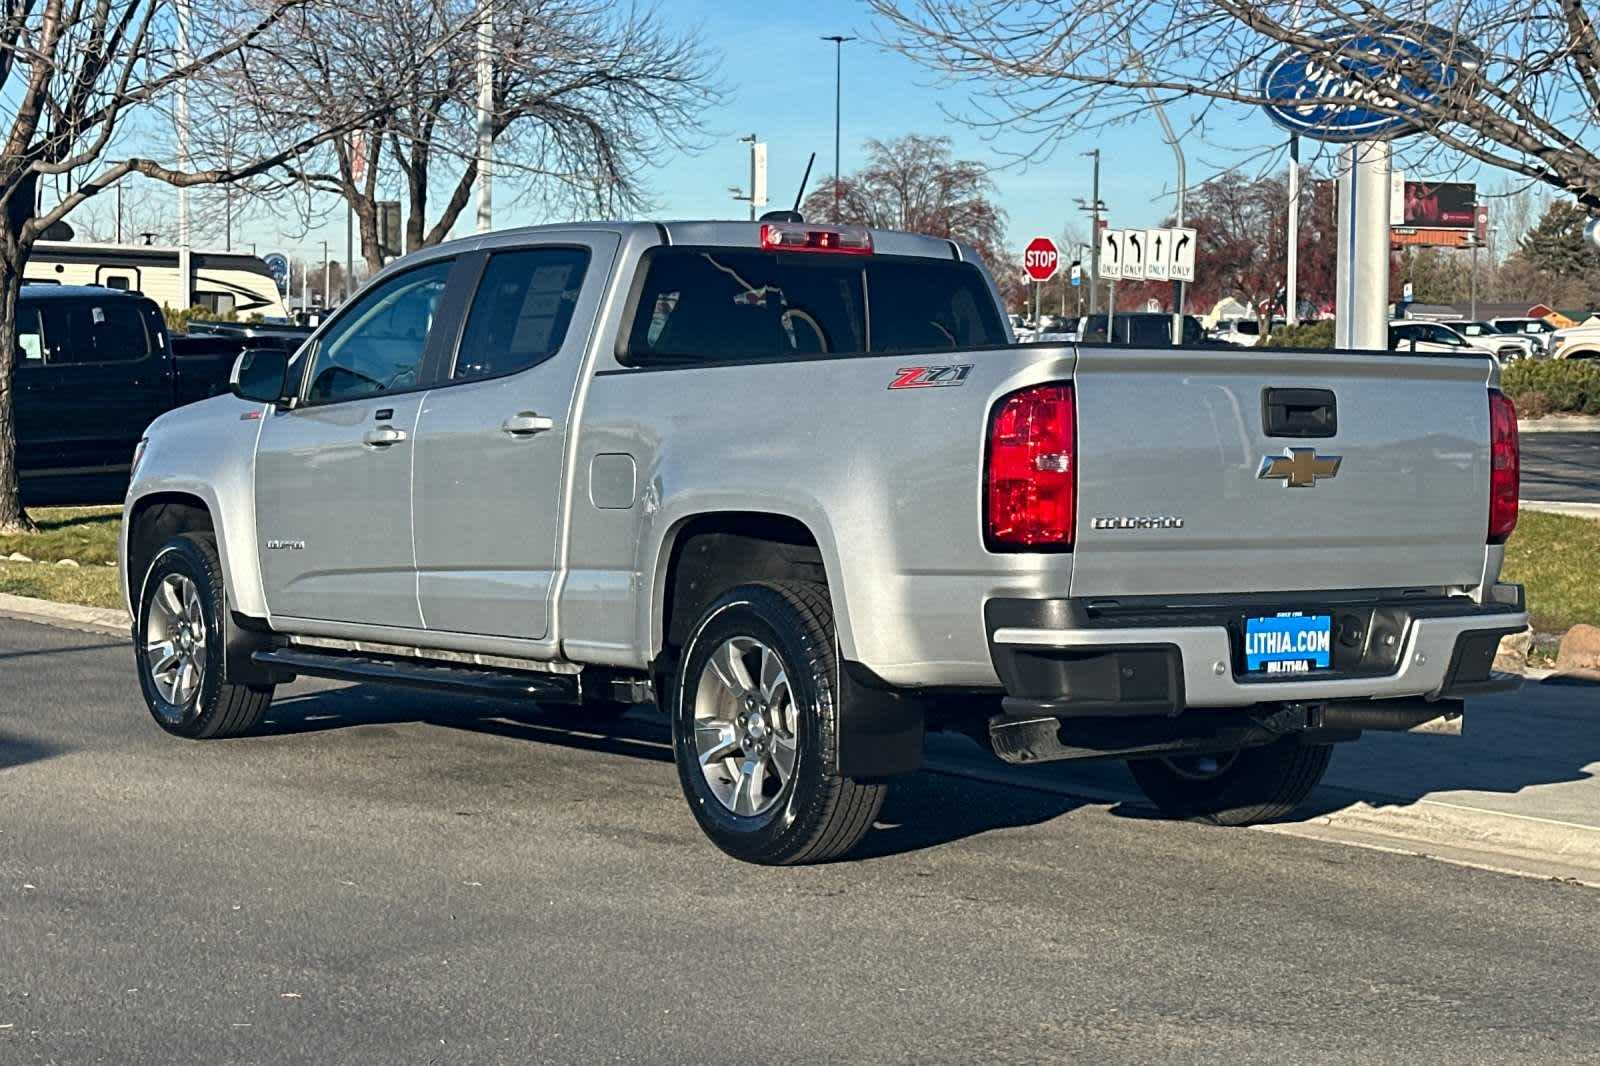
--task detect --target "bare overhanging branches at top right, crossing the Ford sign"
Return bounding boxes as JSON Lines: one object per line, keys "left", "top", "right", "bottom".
{"left": 869, "top": 0, "right": 1600, "bottom": 204}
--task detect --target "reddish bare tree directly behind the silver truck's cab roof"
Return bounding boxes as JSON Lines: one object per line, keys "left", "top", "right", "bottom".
{"left": 805, "top": 134, "right": 1021, "bottom": 274}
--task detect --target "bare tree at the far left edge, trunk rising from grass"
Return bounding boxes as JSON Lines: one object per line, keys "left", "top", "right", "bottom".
{"left": 0, "top": 0, "right": 467, "bottom": 531}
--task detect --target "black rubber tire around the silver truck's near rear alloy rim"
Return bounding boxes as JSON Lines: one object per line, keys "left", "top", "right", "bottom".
{"left": 669, "top": 581, "right": 888, "bottom": 866}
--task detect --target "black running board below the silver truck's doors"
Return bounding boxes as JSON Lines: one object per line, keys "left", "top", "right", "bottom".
{"left": 250, "top": 648, "right": 582, "bottom": 703}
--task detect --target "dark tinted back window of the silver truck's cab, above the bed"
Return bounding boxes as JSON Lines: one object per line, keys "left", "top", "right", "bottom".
{"left": 622, "top": 248, "right": 1006, "bottom": 363}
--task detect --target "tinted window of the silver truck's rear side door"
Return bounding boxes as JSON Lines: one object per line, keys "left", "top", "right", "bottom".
{"left": 451, "top": 248, "right": 589, "bottom": 381}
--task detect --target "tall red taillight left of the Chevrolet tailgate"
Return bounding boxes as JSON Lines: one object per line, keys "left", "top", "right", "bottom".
{"left": 984, "top": 384, "right": 1078, "bottom": 549}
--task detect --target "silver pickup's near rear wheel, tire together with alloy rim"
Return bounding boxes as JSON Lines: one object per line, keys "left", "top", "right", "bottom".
{"left": 670, "top": 581, "right": 888, "bottom": 866}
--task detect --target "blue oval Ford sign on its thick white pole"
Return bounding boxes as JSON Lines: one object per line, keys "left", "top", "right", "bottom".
{"left": 1261, "top": 26, "right": 1456, "bottom": 349}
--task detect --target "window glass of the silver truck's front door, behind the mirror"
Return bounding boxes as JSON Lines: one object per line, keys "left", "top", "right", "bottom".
{"left": 306, "top": 259, "right": 451, "bottom": 403}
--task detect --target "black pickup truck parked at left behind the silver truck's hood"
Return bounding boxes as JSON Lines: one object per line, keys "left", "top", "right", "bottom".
{"left": 13, "top": 285, "right": 297, "bottom": 506}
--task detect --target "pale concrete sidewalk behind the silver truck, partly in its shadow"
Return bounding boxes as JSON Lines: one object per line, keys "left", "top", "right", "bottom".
{"left": 928, "top": 682, "right": 1600, "bottom": 885}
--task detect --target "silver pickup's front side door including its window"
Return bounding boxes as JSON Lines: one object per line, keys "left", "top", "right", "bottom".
{"left": 256, "top": 259, "right": 453, "bottom": 629}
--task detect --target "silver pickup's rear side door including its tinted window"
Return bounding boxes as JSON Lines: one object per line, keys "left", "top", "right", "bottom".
{"left": 416, "top": 234, "right": 619, "bottom": 640}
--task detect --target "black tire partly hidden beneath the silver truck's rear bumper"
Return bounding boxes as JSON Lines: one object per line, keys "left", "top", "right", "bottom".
{"left": 1128, "top": 738, "right": 1333, "bottom": 826}
